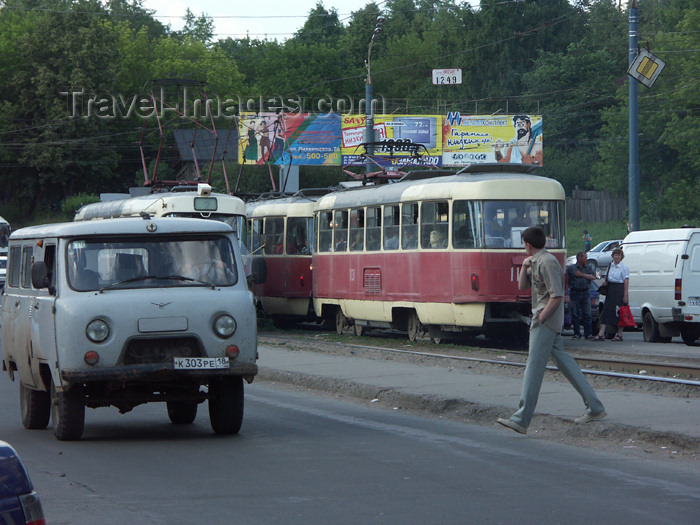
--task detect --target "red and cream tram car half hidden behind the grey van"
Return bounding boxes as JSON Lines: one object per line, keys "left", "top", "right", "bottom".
{"left": 246, "top": 189, "right": 330, "bottom": 328}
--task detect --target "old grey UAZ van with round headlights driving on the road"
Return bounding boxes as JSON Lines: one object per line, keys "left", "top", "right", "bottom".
{"left": 0, "top": 218, "right": 258, "bottom": 440}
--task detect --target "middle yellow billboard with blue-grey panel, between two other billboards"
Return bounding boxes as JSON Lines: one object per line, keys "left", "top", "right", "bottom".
{"left": 340, "top": 115, "right": 442, "bottom": 166}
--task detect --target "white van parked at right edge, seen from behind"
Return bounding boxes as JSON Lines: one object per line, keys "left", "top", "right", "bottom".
{"left": 622, "top": 228, "right": 700, "bottom": 345}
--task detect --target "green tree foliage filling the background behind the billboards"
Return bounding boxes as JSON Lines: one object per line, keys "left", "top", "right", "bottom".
{"left": 0, "top": 0, "right": 700, "bottom": 223}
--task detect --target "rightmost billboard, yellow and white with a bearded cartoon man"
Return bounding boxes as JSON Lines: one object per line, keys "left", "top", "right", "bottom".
{"left": 442, "top": 112, "right": 542, "bottom": 166}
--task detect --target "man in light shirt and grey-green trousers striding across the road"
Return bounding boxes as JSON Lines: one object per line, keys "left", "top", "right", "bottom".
{"left": 498, "top": 227, "right": 607, "bottom": 434}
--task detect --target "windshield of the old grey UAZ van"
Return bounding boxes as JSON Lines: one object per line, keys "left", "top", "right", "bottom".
{"left": 66, "top": 235, "right": 238, "bottom": 291}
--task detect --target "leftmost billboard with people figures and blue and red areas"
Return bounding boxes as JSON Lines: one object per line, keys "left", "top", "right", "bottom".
{"left": 238, "top": 112, "right": 341, "bottom": 166}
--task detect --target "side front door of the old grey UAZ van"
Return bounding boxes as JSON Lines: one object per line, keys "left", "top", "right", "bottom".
{"left": 29, "top": 240, "right": 56, "bottom": 388}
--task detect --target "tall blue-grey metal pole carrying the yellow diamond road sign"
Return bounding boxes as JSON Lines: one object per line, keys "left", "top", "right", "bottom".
{"left": 628, "top": 0, "right": 640, "bottom": 232}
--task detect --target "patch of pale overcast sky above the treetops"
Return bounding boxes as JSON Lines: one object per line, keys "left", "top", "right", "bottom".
{"left": 143, "top": 0, "right": 385, "bottom": 40}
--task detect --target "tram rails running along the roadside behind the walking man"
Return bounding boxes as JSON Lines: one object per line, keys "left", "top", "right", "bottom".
{"left": 264, "top": 334, "right": 700, "bottom": 386}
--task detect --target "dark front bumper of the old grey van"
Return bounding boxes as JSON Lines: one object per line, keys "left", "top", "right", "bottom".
{"left": 61, "top": 363, "right": 258, "bottom": 383}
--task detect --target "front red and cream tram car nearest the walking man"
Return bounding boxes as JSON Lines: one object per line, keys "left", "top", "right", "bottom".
{"left": 313, "top": 164, "right": 566, "bottom": 341}
